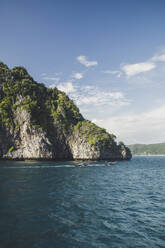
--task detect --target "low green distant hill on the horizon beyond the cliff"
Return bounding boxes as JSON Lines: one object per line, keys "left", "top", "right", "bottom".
{"left": 128, "top": 143, "right": 165, "bottom": 155}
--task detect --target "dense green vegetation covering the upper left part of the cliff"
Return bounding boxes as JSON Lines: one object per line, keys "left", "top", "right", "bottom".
{"left": 0, "top": 63, "right": 83, "bottom": 131}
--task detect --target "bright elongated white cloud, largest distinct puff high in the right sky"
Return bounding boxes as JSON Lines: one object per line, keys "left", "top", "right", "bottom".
{"left": 121, "top": 62, "right": 156, "bottom": 77}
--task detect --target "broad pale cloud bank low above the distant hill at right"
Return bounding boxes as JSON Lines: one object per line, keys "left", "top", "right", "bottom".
{"left": 95, "top": 105, "right": 165, "bottom": 144}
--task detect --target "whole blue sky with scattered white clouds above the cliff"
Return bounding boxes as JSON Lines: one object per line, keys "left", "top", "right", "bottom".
{"left": 0, "top": 0, "right": 165, "bottom": 144}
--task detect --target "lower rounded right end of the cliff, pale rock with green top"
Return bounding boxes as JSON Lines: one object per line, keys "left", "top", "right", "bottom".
{"left": 69, "top": 120, "right": 131, "bottom": 160}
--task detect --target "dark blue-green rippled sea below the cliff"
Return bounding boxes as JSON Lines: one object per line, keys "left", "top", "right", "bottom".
{"left": 0, "top": 157, "right": 165, "bottom": 248}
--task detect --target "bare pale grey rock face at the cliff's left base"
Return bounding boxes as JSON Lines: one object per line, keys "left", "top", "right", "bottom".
{"left": 1, "top": 109, "right": 55, "bottom": 159}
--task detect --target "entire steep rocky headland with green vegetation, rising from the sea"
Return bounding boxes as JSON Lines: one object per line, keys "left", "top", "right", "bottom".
{"left": 0, "top": 63, "right": 131, "bottom": 160}
